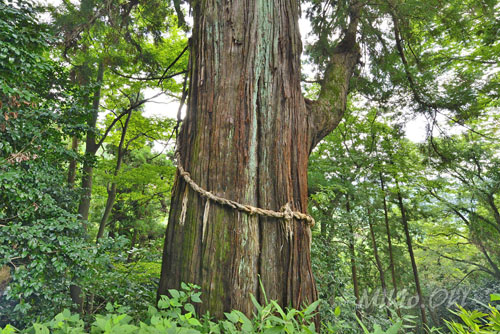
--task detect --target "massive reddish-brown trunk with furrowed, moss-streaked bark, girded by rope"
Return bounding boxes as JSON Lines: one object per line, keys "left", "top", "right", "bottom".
{"left": 158, "top": 0, "right": 357, "bottom": 318}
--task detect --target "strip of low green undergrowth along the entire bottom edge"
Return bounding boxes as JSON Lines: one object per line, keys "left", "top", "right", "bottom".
{"left": 4, "top": 283, "right": 500, "bottom": 334}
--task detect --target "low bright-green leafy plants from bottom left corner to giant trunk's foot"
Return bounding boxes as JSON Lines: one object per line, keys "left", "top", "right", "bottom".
{"left": 0, "top": 283, "right": 319, "bottom": 334}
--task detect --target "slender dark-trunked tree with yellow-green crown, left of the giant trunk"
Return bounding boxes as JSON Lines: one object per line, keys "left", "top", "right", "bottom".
{"left": 52, "top": 0, "right": 186, "bottom": 227}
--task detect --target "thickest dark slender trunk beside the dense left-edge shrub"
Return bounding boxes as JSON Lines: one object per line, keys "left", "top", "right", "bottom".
{"left": 78, "top": 61, "right": 104, "bottom": 222}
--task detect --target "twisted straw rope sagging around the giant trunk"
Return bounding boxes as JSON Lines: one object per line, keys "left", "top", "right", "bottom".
{"left": 175, "top": 151, "right": 315, "bottom": 227}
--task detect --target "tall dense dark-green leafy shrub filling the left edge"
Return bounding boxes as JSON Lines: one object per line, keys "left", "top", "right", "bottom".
{"left": 0, "top": 0, "right": 95, "bottom": 326}
